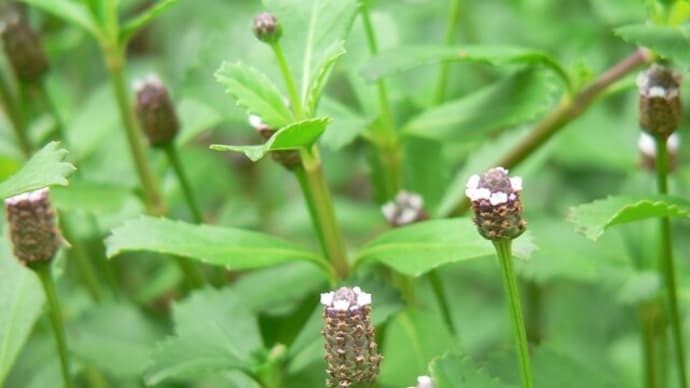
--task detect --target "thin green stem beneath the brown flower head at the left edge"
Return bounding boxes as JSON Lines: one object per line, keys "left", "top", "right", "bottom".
{"left": 34, "top": 262, "right": 74, "bottom": 388}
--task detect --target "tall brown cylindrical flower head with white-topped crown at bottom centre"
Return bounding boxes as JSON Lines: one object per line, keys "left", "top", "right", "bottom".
{"left": 321, "top": 287, "right": 383, "bottom": 388}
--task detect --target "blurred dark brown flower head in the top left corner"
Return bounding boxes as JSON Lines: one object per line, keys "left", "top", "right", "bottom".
{"left": 2, "top": 14, "right": 49, "bottom": 82}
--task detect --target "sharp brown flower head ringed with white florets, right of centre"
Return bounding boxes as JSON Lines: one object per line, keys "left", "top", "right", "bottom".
{"left": 465, "top": 167, "right": 527, "bottom": 240}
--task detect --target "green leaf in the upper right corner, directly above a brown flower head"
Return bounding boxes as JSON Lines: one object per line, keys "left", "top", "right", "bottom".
{"left": 615, "top": 24, "right": 690, "bottom": 69}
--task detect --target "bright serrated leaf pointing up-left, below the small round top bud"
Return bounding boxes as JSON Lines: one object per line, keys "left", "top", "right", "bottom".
{"left": 215, "top": 62, "right": 293, "bottom": 128}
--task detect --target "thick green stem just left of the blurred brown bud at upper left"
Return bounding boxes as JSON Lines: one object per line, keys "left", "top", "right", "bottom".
{"left": 108, "top": 59, "right": 165, "bottom": 215}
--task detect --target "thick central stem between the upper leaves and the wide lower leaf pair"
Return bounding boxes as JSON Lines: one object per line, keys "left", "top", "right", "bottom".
{"left": 298, "top": 146, "right": 349, "bottom": 279}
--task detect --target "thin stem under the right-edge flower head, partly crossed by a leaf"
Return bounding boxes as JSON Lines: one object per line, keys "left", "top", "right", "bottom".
{"left": 655, "top": 136, "right": 688, "bottom": 388}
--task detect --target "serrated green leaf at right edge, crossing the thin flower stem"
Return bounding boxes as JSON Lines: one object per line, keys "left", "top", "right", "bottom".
{"left": 568, "top": 195, "right": 690, "bottom": 240}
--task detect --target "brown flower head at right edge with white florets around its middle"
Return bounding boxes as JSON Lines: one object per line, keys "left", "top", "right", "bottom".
{"left": 637, "top": 64, "right": 682, "bottom": 138}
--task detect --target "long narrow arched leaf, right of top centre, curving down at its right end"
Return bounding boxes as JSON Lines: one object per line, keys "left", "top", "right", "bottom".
{"left": 361, "top": 45, "right": 570, "bottom": 88}
